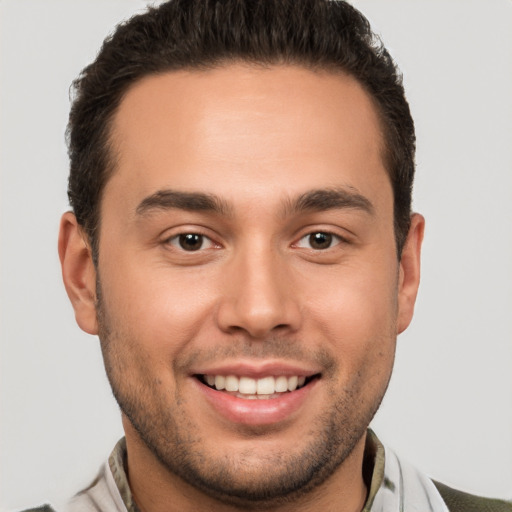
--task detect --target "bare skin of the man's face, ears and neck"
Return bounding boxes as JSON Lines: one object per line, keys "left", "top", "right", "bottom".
{"left": 59, "top": 65, "right": 424, "bottom": 512}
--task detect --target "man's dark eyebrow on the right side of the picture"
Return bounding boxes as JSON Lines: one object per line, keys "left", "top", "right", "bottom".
{"left": 284, "top": 187, "right": 375, "bottom": 216}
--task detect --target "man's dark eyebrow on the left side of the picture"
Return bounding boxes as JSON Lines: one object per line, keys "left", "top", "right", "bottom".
{"left": 136, "top": 190, "right": 231, "bottom": 216}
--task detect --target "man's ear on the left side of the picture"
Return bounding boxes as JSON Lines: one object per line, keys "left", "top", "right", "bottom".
{"left": 59, "top": 212, "right": 98, "bottom": 334}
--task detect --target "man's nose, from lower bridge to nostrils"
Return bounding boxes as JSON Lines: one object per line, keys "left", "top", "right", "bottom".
{"left": 217, "top": 245, "right": 301, "bottom": 339}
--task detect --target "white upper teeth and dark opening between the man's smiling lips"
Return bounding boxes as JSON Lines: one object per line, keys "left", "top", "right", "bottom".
{"left": 195, "top": 374, "right": 320, "bottom": 400}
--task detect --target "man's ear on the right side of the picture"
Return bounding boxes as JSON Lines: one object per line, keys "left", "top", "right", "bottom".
{"left": 397, "top": 213, "right": 425, "bottom": 334}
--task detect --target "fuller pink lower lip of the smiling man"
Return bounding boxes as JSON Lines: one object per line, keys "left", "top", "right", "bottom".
{"left": 194, "top": 378, "right": 318, "bottom": 426}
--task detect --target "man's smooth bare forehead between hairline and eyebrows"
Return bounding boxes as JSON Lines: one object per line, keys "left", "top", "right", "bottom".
{"left": 107, "top": 64, "right": 389, "bottom": 212}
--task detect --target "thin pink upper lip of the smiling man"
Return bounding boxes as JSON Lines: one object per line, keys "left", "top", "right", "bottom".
{"left": 191, "top": 361, "right": 320, "bottom": 379}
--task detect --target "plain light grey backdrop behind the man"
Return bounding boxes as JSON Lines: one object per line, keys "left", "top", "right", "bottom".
{"left": 0, "top": 0, "right": 512, "bottom": 512}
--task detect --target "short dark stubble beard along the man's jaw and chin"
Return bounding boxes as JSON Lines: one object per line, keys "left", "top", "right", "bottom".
{"left": 97, "top": 283, "right": 390, "bottom": 510}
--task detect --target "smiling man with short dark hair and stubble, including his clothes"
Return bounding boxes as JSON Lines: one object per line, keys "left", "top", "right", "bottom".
{"left": 22, "top": 0, "right": 511, "bottom": 511}
